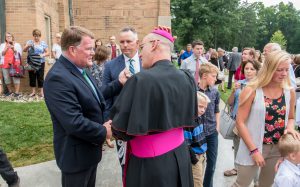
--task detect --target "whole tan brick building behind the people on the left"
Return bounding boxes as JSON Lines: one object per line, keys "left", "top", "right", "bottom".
{"left": 0, "top": 0, "right": 171, "bottom": 91}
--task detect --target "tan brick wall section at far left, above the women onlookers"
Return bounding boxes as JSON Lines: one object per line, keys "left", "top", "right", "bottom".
{"left": 5, "top": 0, "right": 59, "bottom": 92}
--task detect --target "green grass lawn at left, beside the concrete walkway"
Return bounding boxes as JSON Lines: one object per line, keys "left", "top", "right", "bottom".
{"left": 0, "top": 101, "right": 54, "bottom": 167}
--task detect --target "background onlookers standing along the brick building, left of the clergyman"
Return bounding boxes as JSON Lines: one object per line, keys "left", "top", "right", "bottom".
{"left": 0, "top": 29, "right": 121, "bottom": 98}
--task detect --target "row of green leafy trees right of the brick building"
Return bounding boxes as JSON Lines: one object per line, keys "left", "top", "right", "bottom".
{"left": 171, "top": 0, "right": 300, "bottom": 53}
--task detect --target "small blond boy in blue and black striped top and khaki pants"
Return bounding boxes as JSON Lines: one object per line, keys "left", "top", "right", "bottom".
{"left": 184, "top": 91, "right": 210, "bottom": 187}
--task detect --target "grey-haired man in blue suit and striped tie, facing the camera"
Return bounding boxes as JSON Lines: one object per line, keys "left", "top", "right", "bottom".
{"left": 103, "top": 27, "right": 141, "bottom": 171}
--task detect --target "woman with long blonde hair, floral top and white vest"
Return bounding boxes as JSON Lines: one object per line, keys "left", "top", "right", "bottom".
{"left": 233, "top": 51, "right": 300, "bottom": 187}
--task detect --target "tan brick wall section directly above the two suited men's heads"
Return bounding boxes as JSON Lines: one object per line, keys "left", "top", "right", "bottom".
{"left": 73, "top": 0, "right": 170, "bottom": 43}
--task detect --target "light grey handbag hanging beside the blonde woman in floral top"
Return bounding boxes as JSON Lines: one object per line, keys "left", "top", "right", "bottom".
{"left": 220, "top": 104, "right": 235, "bottom": 139}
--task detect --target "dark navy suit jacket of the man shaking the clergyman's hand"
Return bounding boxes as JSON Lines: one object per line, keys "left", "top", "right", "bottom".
{"left": 44, "top": 56, "right": 118, "bottom": 173}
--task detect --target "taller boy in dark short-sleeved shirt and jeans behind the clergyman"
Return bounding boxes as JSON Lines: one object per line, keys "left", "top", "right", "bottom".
{"left": 199, "top": 63, "right": 220, "bottom": 187}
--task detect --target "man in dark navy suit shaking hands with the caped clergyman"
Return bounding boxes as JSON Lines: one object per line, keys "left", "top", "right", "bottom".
{"left": 44, "top": 26, "right": 126, "bottom": 187}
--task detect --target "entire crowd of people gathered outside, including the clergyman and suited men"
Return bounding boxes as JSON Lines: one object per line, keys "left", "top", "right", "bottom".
{"left": 0, "top": 26, "right": 300, "bottom": 187}
